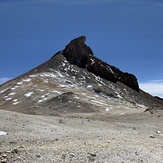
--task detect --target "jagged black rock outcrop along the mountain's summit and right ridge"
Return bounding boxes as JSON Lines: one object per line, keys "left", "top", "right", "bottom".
{"left": 63, "top": 36, "right": 139, "bottom": 92}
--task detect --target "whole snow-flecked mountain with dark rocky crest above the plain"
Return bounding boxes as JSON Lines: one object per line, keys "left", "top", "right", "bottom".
{"left": 0, "top": 36, "right": 162, "bottom": 115}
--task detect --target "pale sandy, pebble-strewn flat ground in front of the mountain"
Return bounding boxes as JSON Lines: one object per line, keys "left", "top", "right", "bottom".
{"left": 0, "top": 110, "right": 163, "bottom": 163}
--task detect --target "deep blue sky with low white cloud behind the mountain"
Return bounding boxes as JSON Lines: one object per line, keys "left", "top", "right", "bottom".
{"left": 0, "top": 0, "right": 163, "bottom": 96}
